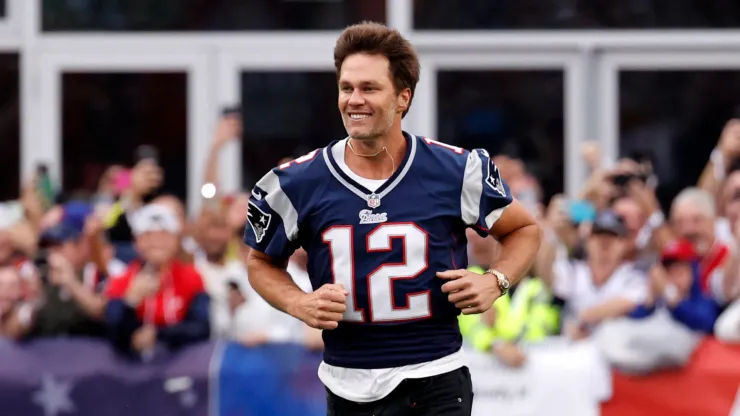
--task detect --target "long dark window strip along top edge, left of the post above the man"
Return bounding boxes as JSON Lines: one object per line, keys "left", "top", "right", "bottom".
{"left": 42, "top": 0, "right": 386, "bottom": 32}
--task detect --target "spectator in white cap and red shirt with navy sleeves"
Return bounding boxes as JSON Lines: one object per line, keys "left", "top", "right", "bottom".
{"left": 106, "top": 204, "right": 210, "bottom": 354}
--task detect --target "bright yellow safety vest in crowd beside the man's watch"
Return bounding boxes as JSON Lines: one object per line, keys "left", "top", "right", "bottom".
{"left": 458, "top": 266, "right": 560, "bottom": 351}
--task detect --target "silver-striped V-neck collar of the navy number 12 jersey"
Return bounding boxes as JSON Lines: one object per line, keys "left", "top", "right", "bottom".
{"left": 324, "top": 132, "right": 417, "bottom": 208}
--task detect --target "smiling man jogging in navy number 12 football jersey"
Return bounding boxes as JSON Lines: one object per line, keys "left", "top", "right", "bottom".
{"left": 245, "top": 23, "right": 540, "bottom": 415}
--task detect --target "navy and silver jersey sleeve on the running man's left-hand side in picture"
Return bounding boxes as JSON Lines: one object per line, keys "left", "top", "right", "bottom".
{"left": 244, "top": 169, "right": 298, "bottom": 259}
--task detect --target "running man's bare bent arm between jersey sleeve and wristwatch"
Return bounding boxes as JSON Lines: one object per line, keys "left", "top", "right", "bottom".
{"left": 489, "top": 200, "right": 542, "bottom": 284}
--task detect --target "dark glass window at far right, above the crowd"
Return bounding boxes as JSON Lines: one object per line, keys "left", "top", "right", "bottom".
{"left": 619, "top": 70, "right": 740, "bottom": 206}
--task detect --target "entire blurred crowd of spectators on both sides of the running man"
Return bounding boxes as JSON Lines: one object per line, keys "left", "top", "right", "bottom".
{"left": 0, "top": 108, "right": 740, "bottom": 373}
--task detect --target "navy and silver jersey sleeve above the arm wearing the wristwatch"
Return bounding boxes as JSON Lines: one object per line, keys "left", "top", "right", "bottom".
{"left": 460, "top": 149, "right": 512, "bottom": 236}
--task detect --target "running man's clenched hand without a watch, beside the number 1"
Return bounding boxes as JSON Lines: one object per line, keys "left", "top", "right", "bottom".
{"left": 288, "top": 284, "right": 349, "bottom": 329}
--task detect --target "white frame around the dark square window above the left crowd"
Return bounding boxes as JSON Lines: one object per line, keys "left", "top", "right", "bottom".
{"left": 34, "top": 48, "right": 214, "bottom": 212}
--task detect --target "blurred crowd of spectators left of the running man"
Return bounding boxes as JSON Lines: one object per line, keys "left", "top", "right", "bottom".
{"left": 0, "top": 114, "right": 322, "bottom": 360}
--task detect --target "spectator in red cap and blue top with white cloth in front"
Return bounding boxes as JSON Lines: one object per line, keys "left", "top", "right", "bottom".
{"left": 596, "top": 239, "right": 720, "bottom": 373}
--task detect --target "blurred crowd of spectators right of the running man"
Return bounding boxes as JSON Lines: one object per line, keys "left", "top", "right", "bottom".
{"left": 461, "top": 119, "right": 740, "bottom": 374}
